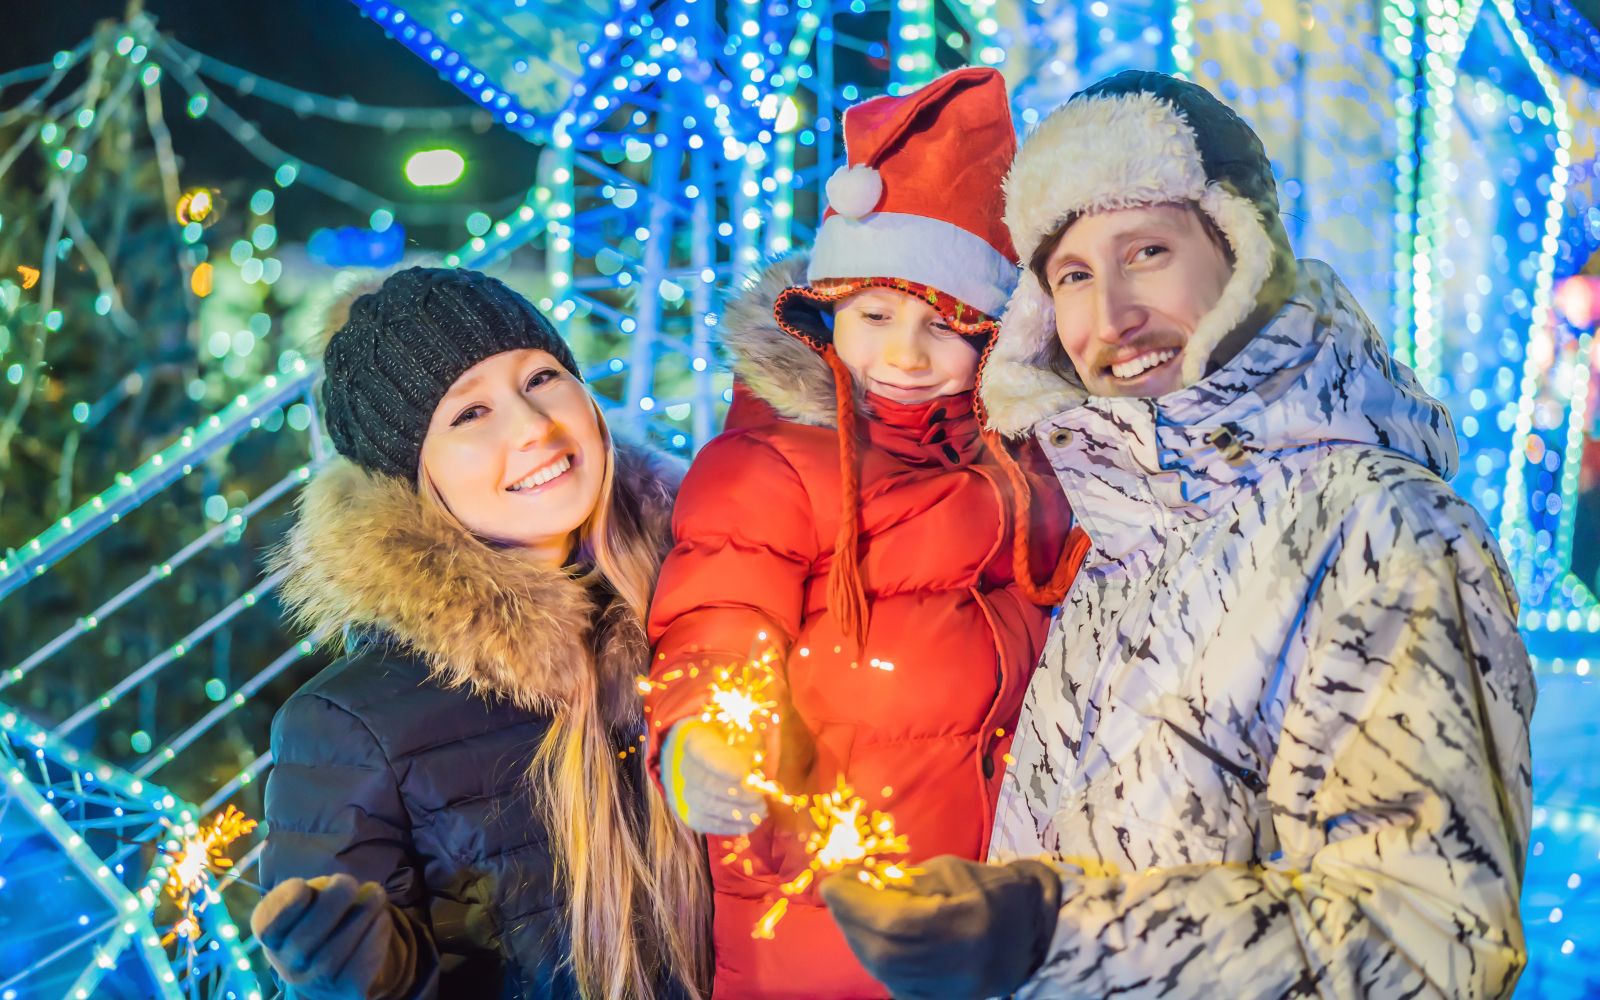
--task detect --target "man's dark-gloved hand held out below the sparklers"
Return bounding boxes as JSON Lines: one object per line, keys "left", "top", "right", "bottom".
{"left": 822, "top": 854, "right": 1061, "bottom": 1000}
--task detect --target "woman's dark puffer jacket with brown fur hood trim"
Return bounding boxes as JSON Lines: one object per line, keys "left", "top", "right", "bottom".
{"left": 261, "top": 448, "right": 677, "bottom": 997}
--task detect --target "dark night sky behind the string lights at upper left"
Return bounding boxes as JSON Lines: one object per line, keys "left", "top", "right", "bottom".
{"left": 0, "top": 0, "right": 538, "bottom": 248}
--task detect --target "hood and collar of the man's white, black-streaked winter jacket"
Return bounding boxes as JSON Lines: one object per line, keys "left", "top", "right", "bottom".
{"left": 1035, "top": 261, "right": 1458, "bottom": 549}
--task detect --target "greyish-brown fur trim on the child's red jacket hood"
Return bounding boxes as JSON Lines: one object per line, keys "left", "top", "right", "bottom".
{"left": 722, "top": 253, "right": 864, "bottom": 427}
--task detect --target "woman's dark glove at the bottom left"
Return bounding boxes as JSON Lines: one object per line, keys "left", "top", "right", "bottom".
{"left": 250, "top": 875, "right": 416, "bottom": 1000}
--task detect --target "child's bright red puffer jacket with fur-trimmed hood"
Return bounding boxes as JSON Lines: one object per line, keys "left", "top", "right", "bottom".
{"left": 645, "top": 258, "right": 1070, "bottom": 998}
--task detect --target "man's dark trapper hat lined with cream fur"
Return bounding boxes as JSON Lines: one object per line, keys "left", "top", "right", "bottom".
{"left": 979, "top": 70, "right": 1294, "bottom": 435}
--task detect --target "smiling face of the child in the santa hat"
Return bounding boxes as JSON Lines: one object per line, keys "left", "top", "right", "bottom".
{"left": 834, "top": 288, "right": 978, "bottom": 403}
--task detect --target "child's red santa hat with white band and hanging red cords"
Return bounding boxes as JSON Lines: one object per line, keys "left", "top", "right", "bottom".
{"left": 773, "top": 67, "right": 1081, "bottom": 643}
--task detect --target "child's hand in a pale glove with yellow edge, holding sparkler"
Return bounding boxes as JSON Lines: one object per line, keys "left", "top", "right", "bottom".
{"left": 661, "top": 718, "right": 766, "bottom": 837}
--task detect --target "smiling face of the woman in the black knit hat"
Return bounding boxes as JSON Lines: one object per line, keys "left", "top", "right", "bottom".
{"left": 422, "top": 349, "right": 606, "bottom": 566}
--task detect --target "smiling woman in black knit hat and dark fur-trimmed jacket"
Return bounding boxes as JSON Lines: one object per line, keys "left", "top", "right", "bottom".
{"left": 251, "top": 267, "right": 709, "bottom": 997}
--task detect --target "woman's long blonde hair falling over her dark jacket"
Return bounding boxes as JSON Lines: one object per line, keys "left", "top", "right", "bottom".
{"left": 418, "top": 397, "right": 710, "bottom": 1000}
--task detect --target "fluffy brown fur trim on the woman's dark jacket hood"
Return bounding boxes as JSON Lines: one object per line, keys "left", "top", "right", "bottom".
{"left": 272, "top": 442, "right": 682, "bottom": 725}
